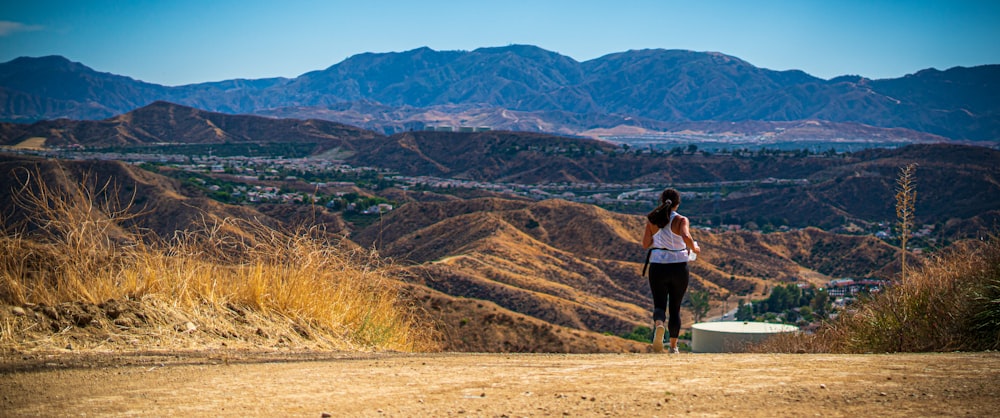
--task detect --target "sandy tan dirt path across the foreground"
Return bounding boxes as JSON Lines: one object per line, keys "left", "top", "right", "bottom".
{"left": 0, "top": 352, "right": 1000, "bottom": 417}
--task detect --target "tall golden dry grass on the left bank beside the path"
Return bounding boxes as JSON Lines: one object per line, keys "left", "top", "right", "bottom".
{"left": 0, "top": 167, "right": 432, "bottom": 351}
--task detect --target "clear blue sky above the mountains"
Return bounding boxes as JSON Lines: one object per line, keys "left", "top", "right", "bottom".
{"left": 0, "top": 0, "right": 1000, "bottom": 85}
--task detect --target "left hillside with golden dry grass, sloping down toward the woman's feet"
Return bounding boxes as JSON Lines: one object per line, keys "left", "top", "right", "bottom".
{"left": 0, "top": 158, "right": 644, "bottom": 352}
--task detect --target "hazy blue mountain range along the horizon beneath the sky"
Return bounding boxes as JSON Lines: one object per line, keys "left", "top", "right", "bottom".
{"left": 0, "top": 45, "right": 1000, "bottom": 140}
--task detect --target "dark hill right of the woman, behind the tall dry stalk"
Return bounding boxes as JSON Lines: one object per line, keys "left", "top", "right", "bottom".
{"left": 696, "top": 144, "right": 1000, "bottom": 232}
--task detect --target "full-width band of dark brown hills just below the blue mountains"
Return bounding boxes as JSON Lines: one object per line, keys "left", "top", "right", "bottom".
{"left": 0, "top": 102, "right": 1000, "bottom": 233}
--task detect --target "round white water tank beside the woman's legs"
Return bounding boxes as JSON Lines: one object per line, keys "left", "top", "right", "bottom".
{"left": 691, "top": 321, "right": 799, "bottom": 353}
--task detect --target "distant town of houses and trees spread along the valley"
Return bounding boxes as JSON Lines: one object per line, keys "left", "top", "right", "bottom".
{"left": 4, "top": 142, "right": 934, "bottom": 245}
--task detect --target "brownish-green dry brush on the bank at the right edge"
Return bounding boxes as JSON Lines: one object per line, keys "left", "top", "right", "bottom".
{"left": 755, "top": 236, "right": 1000, "bottom": 353}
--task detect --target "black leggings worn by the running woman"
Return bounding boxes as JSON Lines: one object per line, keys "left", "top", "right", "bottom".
{"left": 649, "top": 263, "right": 691, "bottom": 338}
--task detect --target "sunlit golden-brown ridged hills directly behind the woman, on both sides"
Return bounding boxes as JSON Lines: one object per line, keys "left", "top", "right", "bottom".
{"left": 352, "top": 195, "right": 908, "bottom": 334}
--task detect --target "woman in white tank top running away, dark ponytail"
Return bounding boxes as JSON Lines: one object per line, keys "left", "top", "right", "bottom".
{"left": 642, "top": 189, "right": 701, "bottom": 354}
